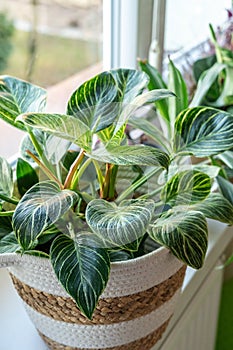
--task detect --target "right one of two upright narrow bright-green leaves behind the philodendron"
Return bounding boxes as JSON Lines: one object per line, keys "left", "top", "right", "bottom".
{"left": 168, "top": 60, "right": 188, "bottom": 129}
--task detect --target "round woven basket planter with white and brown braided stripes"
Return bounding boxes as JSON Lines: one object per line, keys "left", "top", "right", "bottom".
{"left": 0, "top": 248, "right": 186, "bottom": 350}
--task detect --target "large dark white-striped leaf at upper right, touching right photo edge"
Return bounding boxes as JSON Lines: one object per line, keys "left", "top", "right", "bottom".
{"left": 174, "top": 107, "right": 233, "bottom": 157}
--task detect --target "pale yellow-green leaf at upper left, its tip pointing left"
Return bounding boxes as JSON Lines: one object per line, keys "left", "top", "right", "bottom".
{"left": 17, "top": 113, "right": 91, "bottom": 150}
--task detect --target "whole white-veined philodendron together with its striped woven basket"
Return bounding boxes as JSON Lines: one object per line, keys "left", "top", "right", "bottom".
{"left": 0, "top": 69, "right": 233, "bottom": 350}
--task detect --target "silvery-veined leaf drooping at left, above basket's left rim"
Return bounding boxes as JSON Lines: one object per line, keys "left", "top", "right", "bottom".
{"left": 12, "top": 181, "right": 79, "bottom": 250}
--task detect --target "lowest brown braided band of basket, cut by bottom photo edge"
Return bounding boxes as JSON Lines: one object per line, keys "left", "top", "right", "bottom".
{"left": 39, "top": 320, "right": 169, "bottom": 350}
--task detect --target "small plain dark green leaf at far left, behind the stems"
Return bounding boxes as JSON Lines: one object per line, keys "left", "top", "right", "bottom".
{"left": 16, "top": 158, "right": 39, "bottom": 196}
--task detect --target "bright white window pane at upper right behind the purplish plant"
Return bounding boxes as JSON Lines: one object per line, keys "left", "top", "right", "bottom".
{"left": 165, "top": 0, "right": 231, "bottom": 54}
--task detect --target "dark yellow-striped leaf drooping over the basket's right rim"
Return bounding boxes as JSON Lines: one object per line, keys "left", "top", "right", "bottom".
{"left": 148, "top": 209, "right": 208, "bottom": 269}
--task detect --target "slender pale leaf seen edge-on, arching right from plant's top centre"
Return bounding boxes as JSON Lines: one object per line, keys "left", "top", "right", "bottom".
{"left": 114, "top": 89, "right": 175, "bottom": 134}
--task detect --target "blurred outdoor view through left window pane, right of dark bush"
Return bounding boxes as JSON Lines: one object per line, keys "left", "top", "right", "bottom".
{"left": 0, "top": 0, "right": 102, "bottom": 87}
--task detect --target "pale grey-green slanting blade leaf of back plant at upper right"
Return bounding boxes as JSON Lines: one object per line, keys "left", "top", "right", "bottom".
{"left": 189, "top": 62, "right": 226, "bottom": 107}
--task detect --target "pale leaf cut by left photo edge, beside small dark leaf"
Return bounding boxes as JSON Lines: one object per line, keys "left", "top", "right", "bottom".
{"left": 0, "top": 157, "right": 14, "bottom": 202}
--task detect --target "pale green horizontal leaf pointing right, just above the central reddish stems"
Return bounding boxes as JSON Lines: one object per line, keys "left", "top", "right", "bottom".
{"left": 87, "top": 146, "right": 170, "bottom": 168}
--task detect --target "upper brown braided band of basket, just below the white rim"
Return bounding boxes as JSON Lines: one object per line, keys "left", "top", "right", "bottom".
{"left": 11, "top": 266, "right": 186, "bottom": 325}
